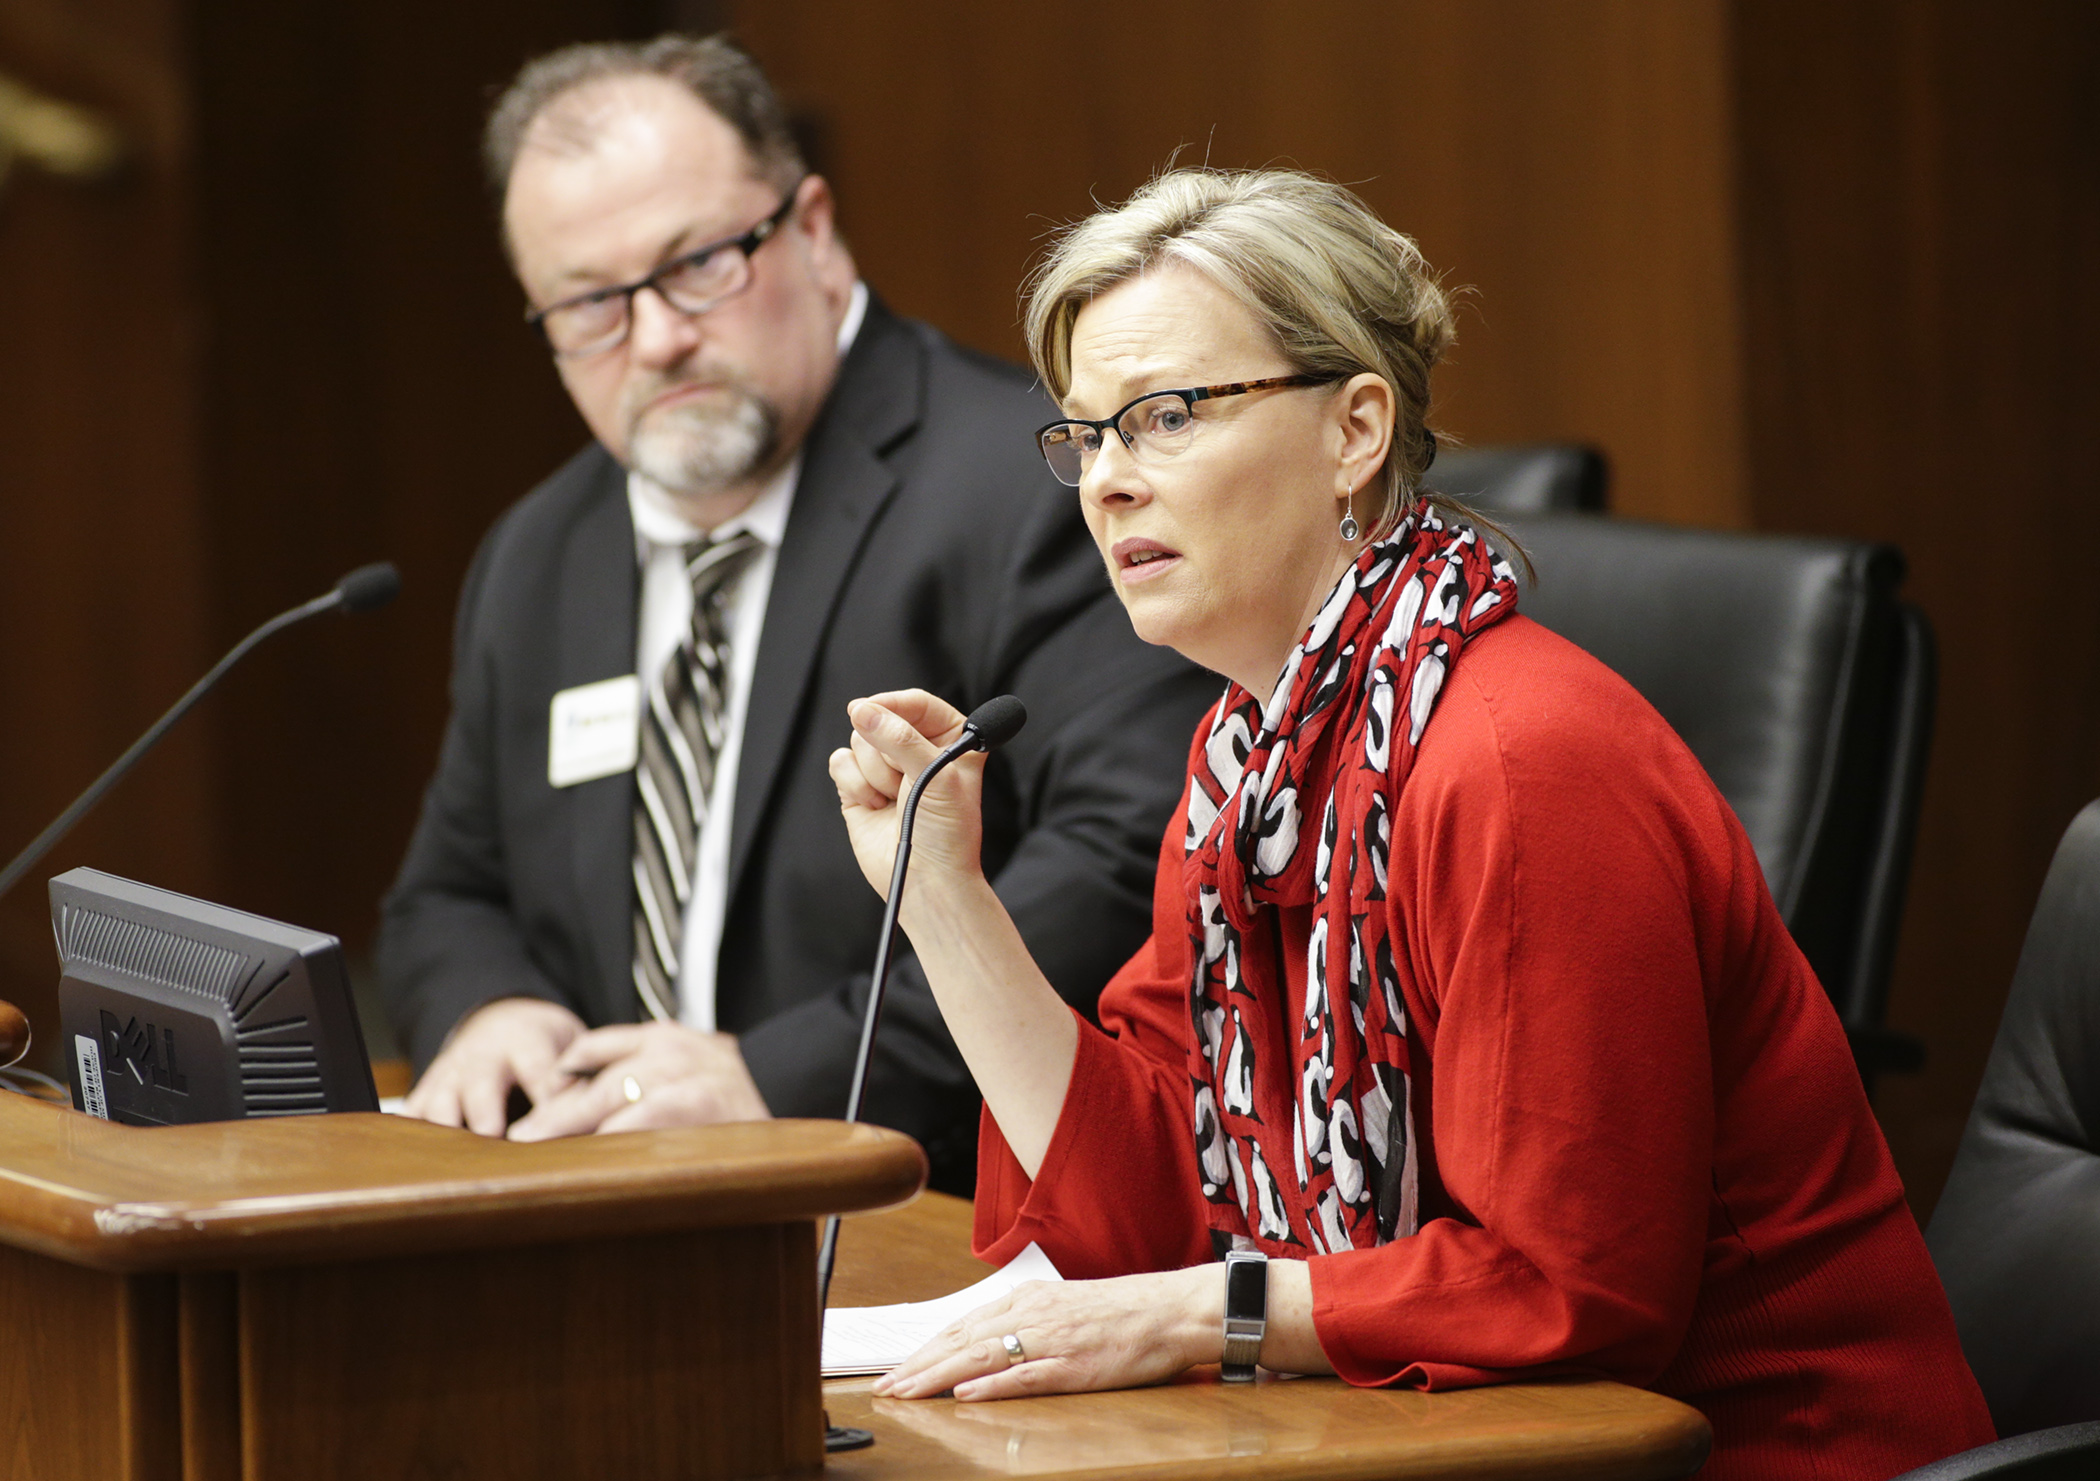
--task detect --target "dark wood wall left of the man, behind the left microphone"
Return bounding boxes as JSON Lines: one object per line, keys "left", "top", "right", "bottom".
{"left": 0, "top": 0, "right": 659, "bottom": 1067}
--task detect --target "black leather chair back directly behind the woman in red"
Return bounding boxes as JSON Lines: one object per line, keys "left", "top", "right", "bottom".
{"left": 1510, "top": 515, "right": 1936, "bottom": 1088}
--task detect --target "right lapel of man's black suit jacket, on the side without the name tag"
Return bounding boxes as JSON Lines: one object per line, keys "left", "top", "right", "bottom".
{"left": 729, "top": 296, "right": 926, "bottom": 903}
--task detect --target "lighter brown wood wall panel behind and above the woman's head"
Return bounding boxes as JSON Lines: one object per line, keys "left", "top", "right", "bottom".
{"left": 725, "top": 0, "right": 1749, "bottom": 525}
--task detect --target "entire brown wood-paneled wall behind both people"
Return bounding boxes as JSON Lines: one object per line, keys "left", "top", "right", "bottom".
{"left": 0, "top": 0, "right": 2100, "bottom": 1210}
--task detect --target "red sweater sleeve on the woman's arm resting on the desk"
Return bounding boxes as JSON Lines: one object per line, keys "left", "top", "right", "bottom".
{"left": 1310, "top": 647, "right": 1738, "bottom": 1389}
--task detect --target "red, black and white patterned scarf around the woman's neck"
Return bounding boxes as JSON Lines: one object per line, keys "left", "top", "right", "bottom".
{"left": 1182, "top": 508, "right": 1516, "bottom": 1256}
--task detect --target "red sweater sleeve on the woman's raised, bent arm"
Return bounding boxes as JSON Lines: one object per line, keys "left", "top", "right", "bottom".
{"left": 972, "top": 798, "right": 1212, "bottom": 1279}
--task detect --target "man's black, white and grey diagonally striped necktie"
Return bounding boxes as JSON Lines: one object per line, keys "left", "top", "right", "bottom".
{"left": 634, "top": 531, "right": 760, "bottom": 1023}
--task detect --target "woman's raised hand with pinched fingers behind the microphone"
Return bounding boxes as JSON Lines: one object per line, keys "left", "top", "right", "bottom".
{"left": 832, "top": 689, "right": 985, "bottom": 897}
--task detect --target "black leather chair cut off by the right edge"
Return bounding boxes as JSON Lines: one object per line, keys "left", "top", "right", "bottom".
{"left": 1926, "top": 802, "right": 2100, "bottom": 1436}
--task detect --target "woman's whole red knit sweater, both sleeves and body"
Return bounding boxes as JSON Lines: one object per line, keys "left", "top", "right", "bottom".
{"left": 977, "top": 616, "right": 1991, "bottom": 1481}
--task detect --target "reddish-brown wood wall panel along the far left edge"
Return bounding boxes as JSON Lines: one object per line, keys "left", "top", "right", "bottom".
{"left": 0, "top": 0, "right": 223, "bottom": 1063}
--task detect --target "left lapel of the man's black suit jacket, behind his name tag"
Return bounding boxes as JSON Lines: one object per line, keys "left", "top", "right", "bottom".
{"left": 554, "top": 456, "right": 641, "bottom": 1023}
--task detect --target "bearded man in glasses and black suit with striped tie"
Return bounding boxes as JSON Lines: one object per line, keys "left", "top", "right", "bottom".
{"left": 380, "top": 38, "right": 1216, "bottom": 1187}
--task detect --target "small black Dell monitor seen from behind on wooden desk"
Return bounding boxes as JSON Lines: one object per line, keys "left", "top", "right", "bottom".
{"left": 50, "top": 870, "right": 378, "bottom": 1126}
